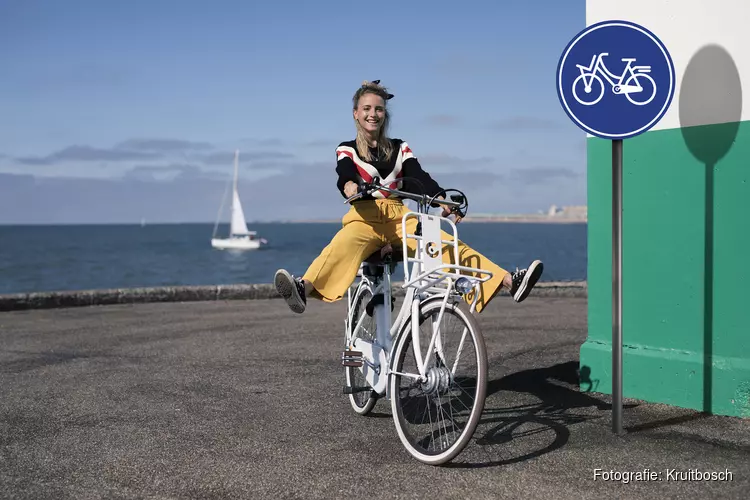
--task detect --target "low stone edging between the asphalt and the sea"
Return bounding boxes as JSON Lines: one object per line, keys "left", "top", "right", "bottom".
{"left": 0, "top": 281, "right": 587, "bottom": 311}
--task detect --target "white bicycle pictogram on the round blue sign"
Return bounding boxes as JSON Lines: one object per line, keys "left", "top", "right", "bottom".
{"left": 573, "top": 52, "right": 656, "bottom": 106}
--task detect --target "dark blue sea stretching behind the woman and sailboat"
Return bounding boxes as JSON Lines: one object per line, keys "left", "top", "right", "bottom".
{"left": 0, "top": 221, "right": 587, "bottom": 294}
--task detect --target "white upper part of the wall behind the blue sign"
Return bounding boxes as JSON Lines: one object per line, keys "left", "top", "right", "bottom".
{"left": 586, "top": 0, "right": 750, "bottom": 130}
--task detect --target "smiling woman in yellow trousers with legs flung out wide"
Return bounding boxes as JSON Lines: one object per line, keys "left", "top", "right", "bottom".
{"left": 274, "top": 80, "right": 543, "bottom": 313}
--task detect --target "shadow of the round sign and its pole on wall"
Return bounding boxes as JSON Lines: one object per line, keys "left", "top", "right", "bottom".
{"left": 679, "top": 45, "right": 742, "bottom": 413}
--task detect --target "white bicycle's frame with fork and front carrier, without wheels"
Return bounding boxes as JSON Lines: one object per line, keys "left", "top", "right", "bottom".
{"left": 345, "top": 188, "right": 492, "bottom": 399}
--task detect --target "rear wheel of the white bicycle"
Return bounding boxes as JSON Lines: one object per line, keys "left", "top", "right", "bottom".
{"left": 344, "top": 286, "right": 378, "bottom": 415}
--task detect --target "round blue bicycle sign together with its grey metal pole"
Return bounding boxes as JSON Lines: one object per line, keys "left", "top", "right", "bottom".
{"left": 556, "top": 19, "right": 676, "bottom": 435}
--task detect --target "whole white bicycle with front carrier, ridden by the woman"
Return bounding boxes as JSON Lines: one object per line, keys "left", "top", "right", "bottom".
{"left": 341, "top": 180, "right": 492, "bottom": 465}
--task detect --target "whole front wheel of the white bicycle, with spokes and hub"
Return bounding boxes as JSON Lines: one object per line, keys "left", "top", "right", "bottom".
{"left": 389, "top": 299, "right": 487, "bottom": 465}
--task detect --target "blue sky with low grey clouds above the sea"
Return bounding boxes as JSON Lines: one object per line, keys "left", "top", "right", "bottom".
{"left": 0, "top": 0, "right": 586, "bottom": 224}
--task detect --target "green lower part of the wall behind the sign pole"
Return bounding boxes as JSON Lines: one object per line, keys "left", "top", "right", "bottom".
{"left": 581, "top": 122, "right": 750, "bottom": 416}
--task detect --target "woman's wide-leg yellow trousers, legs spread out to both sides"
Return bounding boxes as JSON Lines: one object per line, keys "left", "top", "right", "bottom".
{"left": 302, "top": 199, "right": 508, "bottom": 312}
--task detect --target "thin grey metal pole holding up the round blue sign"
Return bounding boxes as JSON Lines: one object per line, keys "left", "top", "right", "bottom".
{"left": 612, "top": 139, "right": 622, "bottom": 435}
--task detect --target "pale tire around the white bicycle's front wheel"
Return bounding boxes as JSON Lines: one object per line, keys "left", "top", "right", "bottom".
{"left": 389, "top": 297, "right": 488, "bottom": 465}
